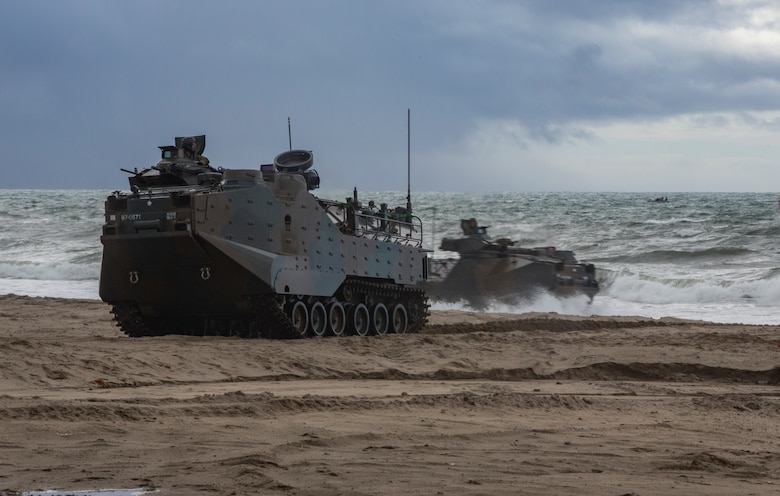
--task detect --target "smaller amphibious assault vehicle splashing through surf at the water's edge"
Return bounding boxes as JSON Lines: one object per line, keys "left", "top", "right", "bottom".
{"left": 424, "top": 218, "right": 599, "bottom": 309}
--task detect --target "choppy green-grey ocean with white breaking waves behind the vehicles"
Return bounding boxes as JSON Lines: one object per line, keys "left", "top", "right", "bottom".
{"left": 0, "top": 190, "right": 780, "bottom": 325}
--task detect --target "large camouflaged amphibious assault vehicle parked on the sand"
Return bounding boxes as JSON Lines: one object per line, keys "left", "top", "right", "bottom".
{"left": 100, "top": 136, "right": 428, "bottom": 338}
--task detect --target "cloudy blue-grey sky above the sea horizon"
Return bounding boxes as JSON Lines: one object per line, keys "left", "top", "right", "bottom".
{"left": 0, "top": 0, "right": 780, "bottom": 192}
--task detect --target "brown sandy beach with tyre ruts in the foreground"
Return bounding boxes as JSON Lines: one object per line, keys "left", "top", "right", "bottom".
{"left": 0, "top": 296, "right": 780, "bottom": 496}
